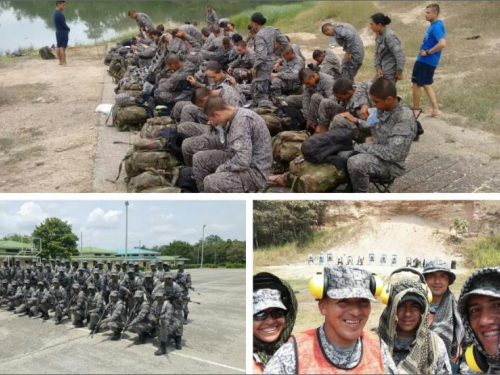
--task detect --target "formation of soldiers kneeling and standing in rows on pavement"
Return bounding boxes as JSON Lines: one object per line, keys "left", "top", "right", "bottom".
{"left": 0, "top": 258, "right": 199, "bottom": 355}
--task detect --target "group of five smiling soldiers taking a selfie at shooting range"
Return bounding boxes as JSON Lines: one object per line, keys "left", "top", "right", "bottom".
{"left": 253, "top": 259, "right": 500, "bottom": 374}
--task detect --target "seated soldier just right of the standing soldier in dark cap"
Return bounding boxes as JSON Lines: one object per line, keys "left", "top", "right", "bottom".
{"left": 270, "top": 45, "right": 304, "bottom": 97}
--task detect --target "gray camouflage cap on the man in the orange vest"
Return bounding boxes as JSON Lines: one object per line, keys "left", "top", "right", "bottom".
{"left": 325, "top": 266, "right": 377, "bottom": 302}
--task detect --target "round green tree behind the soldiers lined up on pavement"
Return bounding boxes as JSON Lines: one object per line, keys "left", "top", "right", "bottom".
{"left": 32, "top": 217, "right": 78, "bottom": 258}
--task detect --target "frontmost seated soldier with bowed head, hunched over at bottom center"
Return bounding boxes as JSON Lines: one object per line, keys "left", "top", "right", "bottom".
{"left": 193, "top": 97, "right": 272, "bottom": 193}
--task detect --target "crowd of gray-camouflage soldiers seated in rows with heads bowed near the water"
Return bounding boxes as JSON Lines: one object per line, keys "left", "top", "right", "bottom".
{"left": 107, "top": 7, "right": 417, "bottom": 193}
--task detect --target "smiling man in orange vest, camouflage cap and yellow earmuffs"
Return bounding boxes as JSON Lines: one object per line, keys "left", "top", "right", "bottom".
{"left": 264, "top": 266, "right": 396, "bottom": 374}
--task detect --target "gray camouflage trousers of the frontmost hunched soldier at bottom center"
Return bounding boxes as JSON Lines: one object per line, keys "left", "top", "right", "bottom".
{"left": 193, "top": 150, "right": 264, "bottom": 193}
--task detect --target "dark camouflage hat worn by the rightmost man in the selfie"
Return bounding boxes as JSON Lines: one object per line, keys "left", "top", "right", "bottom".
{"left": 458, "top": 267, "right": 500, "bottom": 316}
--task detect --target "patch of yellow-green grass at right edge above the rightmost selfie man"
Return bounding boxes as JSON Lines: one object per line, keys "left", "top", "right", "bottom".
{"left": 462, "top": 235, "right": 500, "bottom": 268}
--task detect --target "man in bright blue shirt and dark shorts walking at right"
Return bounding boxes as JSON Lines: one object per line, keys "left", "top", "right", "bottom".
{"left": 411, "top": 4, "right": 446, "bottom": 117}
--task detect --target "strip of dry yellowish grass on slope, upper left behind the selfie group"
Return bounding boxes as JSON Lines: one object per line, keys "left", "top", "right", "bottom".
{"left": 254, "top": 224, "right": 356, "bottom": 267}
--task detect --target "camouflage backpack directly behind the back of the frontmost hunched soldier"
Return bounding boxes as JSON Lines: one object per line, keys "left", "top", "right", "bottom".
{"left": 273, "top": 131, "right": 309, "bottom": 173}
